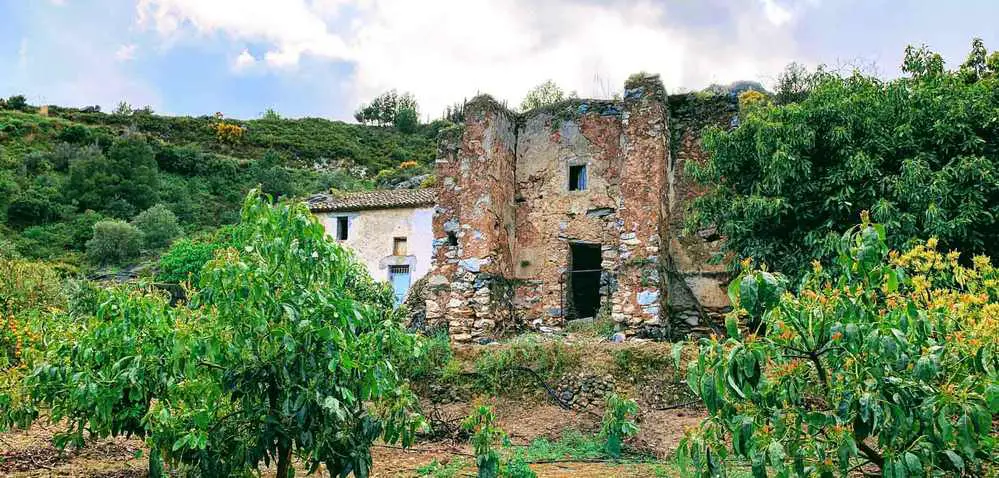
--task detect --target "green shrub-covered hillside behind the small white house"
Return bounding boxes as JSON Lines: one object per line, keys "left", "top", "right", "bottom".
{"left": 0, "top": 102, "right": 439, "bottom": 271}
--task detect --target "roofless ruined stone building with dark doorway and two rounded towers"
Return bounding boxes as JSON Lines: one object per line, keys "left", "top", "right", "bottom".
{"left": 426, "top": 76, "right": 736, "bottom": 341}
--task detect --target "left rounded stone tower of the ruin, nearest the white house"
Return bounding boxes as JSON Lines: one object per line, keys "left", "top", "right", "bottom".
{"left": 426, "top": 97, "right": 516, "bottom": 341}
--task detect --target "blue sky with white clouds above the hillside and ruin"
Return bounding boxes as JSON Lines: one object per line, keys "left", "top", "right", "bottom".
{"left": 0, "top": 0, "right": 999, "bottom": 120}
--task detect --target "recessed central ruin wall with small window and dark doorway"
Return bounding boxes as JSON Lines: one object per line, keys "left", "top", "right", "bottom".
{"left": 514, "top": 100, "right": 623, "bottom": 326}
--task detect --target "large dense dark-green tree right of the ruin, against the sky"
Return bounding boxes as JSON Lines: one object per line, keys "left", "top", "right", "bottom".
{"left": 687, "top": 41, "right": 999, "bottom": 279}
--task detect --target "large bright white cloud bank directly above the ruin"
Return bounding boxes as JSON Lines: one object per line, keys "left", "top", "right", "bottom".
{"left": 137, "top": 0, "right": 815, "bottom": 116}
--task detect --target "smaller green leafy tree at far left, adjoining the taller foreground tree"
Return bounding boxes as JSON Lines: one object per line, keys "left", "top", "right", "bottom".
{"left": 27, "top": 286, "right": 186, "bottom": 477}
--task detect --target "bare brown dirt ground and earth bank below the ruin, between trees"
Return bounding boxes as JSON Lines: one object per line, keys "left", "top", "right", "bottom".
{"left": 0, "top": 337, "right": 704, "bottom": 478}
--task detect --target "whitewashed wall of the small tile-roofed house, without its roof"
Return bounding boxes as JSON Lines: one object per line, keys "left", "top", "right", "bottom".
{"left": 316, "top": 207, "right": 434, "bottom": 283}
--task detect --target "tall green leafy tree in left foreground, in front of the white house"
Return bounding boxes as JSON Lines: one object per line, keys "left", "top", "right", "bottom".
{"left": 151, "top": 194, "right": 422, "bottom": 477}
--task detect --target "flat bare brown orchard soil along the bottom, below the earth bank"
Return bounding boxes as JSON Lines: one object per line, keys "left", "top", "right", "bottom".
{"left": 0, "top": 399, "right": 702, "bottom": 478}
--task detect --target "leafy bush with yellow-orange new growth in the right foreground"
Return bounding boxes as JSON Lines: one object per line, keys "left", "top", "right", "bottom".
{"left": 678, "top": 217, "right": 999, "bottom": 476}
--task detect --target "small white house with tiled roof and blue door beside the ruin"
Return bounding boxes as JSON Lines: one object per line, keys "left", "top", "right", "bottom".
{"left": 308, "top": 189, "right": 436, "bottom": 303}
